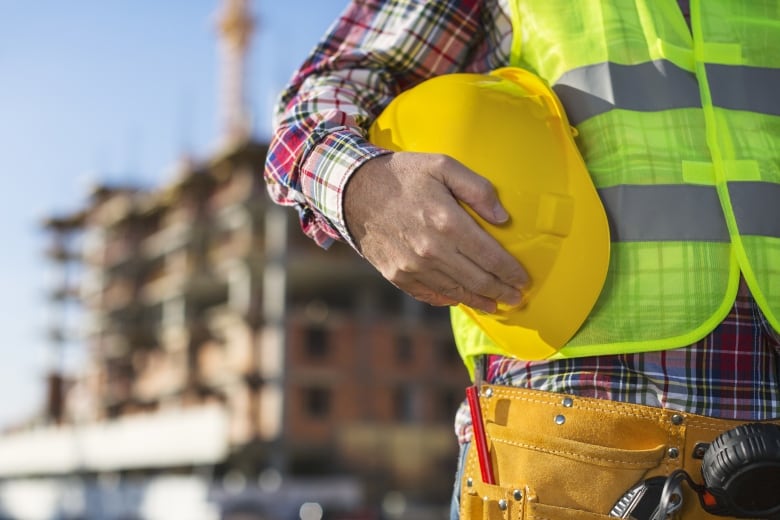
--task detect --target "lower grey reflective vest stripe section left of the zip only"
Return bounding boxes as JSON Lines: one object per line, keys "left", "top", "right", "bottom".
{"left": 598, "top": 184, "right": 730, "bottom": 242}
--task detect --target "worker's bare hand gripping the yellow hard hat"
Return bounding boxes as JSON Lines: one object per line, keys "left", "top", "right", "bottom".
{"left": 344, "top": 152, "right": 528, "bottom": 312}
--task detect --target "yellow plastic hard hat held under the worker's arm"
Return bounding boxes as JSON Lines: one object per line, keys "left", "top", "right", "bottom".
{"left": 369, "top": 67, "right": 610, "bottom": 359}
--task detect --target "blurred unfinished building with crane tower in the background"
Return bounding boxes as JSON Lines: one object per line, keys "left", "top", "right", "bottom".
{"left": 0, "top": 0, "right": 467, "bottom": 520}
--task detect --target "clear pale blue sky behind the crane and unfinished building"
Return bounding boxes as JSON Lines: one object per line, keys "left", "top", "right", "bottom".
{"left": 0, "top": 0, "right": 347, "bottom": 427}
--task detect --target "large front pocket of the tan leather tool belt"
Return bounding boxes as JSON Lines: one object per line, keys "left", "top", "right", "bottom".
{"left": 461, "top": 423, "right": 666, "bottom": 520}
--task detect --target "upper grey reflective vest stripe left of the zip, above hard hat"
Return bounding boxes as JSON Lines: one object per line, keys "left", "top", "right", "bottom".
{"left": 553, "top": 60, "right": 701, "bottom": 126}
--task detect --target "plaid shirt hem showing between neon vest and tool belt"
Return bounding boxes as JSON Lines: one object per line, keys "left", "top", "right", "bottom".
{"left": 455, "top": 281, "right": 780, "bottom": 443}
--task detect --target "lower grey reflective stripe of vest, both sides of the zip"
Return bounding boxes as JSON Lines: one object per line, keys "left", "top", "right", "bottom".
{"left": 598, "top": 182, "right": 780, "bottom": 242}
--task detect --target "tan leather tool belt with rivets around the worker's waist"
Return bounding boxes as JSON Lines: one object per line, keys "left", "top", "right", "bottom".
{"left": 460, "top": 385, "right": 780, "bottom": 520}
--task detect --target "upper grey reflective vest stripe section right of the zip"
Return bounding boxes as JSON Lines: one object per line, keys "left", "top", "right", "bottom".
{"left": 705, "top": 64, "right": 780, "bottom": 116}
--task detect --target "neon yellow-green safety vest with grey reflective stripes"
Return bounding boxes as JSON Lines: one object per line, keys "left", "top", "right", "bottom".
{"left": 452, "top": 0, "right": 780, "bottom": 370}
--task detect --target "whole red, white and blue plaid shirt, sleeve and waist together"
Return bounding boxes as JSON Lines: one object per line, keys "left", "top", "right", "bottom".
{"left": 265, "top": 0, "right": 780, "bottom": 441}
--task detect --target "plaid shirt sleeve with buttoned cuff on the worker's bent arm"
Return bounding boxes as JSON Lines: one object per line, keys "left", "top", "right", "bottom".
{"left": 265, "top": 0, "right": 484, "bottom": 247}
